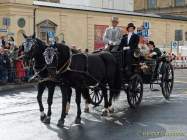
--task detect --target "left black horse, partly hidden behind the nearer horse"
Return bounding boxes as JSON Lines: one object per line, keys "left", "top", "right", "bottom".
{"left": 20, "top": 34, "right": 71, "bottom": 124}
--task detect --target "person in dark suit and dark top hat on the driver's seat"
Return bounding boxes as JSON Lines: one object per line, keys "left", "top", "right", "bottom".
{"left": 119, "top": 23, "right": 139, "bottom": 74}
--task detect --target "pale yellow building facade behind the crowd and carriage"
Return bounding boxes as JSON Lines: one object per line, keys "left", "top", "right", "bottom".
{"left": 0, "top": 0, "right": 187, "bottom": 50}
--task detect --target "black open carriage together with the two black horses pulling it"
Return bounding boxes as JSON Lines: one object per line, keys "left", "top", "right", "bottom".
{"left": 23, "top": 35, "right": 174, "bottom": 127}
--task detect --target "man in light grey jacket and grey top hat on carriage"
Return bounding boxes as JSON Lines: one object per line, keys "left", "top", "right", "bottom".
{"left": 103, "top": 16, "right": 123, "bottom": 51}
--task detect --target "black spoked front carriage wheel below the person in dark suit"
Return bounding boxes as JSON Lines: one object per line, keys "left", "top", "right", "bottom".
{"left": 127, "top": 74, "right": 143, "bottom": 108}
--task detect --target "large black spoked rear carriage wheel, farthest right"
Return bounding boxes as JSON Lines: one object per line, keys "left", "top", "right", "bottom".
{"left": 161, "top": 63, "right": 174, "bottom": 100}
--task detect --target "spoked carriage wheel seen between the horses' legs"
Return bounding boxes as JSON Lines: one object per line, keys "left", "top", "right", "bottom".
{"left": 89, "top": 87, "right": 103, "bottom": 106}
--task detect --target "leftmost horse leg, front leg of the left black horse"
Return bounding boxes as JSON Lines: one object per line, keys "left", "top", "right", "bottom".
{"left": 37, "top": 83, "right": 46, "bottom": 122}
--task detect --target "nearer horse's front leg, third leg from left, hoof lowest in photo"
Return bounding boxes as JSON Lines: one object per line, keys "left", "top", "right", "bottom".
{"left": 57, "top": 85, "right": 70, "bottom": 128}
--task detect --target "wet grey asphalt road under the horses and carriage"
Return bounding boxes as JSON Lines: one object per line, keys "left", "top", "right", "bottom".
{"left": 0, "top": 70, "right": 187, "bottom": 140}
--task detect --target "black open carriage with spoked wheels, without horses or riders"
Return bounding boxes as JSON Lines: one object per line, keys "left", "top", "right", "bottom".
{"left": 90, "top": 51, "right": 174, "bottom": 108}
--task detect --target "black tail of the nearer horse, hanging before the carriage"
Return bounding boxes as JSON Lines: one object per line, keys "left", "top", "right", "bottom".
{"left": 113, "top": 64, "right": 122, "bottom": 100}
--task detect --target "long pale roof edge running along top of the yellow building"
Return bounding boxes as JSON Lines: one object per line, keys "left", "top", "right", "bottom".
{"left": 33, "top": 1, "right": 187, "bottom": 21}
